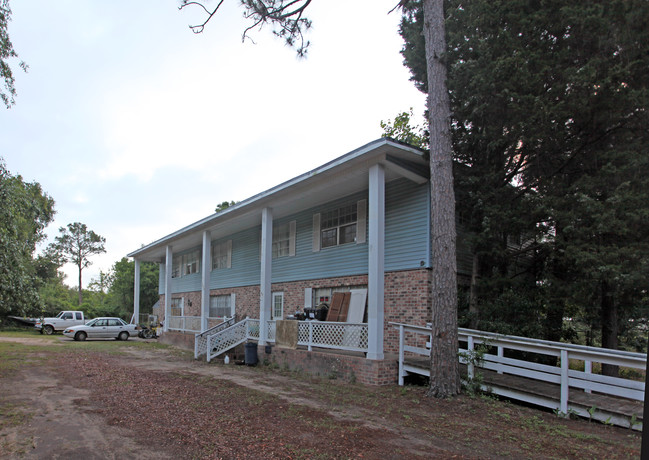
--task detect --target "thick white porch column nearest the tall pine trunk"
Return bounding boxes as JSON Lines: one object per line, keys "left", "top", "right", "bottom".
{"left": 367, "top": 164, "right": 385, "bottom": 359}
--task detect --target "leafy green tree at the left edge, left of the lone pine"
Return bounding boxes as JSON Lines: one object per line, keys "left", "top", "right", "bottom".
{"left": 0, "top": 158, "right": 54, "bottom": 316}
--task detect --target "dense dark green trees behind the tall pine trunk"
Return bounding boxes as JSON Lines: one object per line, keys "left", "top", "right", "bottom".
{"left": 401, "top": 0, "right": 649, "bottom": 362}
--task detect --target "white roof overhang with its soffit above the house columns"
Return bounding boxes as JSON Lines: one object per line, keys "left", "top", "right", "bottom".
{"left": 128, "top": 138, "right": 429, "bottom": 262}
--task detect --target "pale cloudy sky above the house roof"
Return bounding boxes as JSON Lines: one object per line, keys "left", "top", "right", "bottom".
{"left": 0, "top": 0, "right": 425, "bottom": 287}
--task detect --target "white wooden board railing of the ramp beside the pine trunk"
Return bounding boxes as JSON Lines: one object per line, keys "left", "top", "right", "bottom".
{"left": 390, "top": 323, "right": 647, "bottom": 428}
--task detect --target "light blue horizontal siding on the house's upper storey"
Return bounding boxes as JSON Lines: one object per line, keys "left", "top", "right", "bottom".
{"left": 160, "top": 179, "right": 430, "bottom": 293}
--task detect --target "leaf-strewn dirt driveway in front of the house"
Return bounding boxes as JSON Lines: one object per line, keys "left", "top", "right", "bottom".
{"left": 0, "top": 334, "right": 640, "bottom": 459}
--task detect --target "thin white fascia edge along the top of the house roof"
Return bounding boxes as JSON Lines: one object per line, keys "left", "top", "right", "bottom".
{"left": 127, "top": 137, "right": 425, "bottom": 257}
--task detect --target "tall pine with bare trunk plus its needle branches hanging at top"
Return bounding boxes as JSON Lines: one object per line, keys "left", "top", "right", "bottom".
{"left": 180, "top": 0, "right": 460, "bottom": 397}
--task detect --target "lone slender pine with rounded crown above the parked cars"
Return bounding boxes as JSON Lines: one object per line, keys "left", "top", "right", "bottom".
{"left": 50, "top": 222, "right": 106, "bottom": 305}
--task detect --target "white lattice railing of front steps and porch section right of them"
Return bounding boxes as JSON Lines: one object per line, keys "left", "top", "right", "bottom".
{"left": 204, "top": 318, "right": 367, "bottom": 361}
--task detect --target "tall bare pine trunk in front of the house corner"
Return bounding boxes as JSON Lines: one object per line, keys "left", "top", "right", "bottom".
{"left": 423, "top": 0, "right": 460, "bottom": 398}
